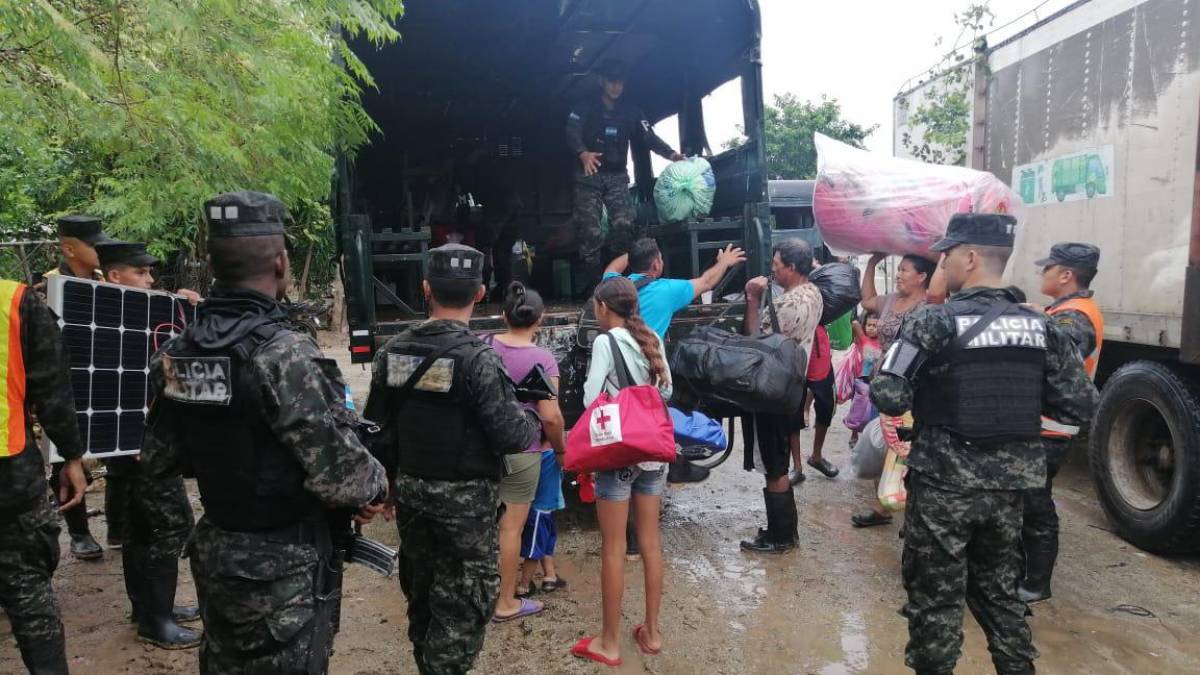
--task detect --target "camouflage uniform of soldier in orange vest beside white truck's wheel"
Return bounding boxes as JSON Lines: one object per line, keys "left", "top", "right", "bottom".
{"left": 1021, "top": 291, "right": 1096, "bottom": 587}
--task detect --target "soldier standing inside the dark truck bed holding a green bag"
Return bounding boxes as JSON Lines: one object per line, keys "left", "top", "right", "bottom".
{"left": 566, "top": 59, "right": 684, "bottom": 281}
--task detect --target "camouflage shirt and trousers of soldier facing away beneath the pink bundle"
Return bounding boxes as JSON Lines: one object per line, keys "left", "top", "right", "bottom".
{"left": 871, "top": 288, "right": 1097, "bottom": 674}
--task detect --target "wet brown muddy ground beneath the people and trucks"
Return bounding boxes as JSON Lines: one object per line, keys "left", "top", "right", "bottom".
{"left": 0, "top": 333, "right": 1200, "bottom": 675}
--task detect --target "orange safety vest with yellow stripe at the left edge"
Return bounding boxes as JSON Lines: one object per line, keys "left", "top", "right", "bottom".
{"left": 0, "top": 280, "right": 25, "bottom": 458}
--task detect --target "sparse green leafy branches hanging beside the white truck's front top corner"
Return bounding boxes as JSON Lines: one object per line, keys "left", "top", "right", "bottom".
{"left": 900, "top": 1, "right": 995, "bottom": 166}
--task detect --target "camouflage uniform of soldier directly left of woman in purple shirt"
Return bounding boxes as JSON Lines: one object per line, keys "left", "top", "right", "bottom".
{"left": 364, "top": 319, "right": 541, "bottom": 675}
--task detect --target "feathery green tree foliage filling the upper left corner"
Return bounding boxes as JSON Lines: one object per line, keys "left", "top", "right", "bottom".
{"left": 0, "top": 0, "right": 403, "bottom": 289}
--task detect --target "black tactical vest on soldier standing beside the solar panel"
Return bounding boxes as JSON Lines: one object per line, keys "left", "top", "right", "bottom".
{"left": 156, "top": 324, "right": 320, "bottom": 532}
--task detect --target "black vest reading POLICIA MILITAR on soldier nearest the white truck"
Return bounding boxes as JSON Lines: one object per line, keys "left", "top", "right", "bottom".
{"left": 913, "top": 298, "right": 1046, "bottom": 443}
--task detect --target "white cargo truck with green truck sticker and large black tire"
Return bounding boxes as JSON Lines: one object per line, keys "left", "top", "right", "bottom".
{"left": 895, "top": 0, "right": 1200, "bottom": 552}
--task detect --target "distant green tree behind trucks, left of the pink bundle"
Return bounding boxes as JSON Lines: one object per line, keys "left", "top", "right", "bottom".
{"left": 724, "top": 94, "right": 878, "bottom": 179}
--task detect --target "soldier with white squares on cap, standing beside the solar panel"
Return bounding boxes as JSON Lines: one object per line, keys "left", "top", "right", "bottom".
{"left": 130, "top": 192, "right": 386, "bottom": 674}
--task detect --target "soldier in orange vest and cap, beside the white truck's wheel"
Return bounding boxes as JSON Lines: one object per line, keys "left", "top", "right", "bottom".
{"left": 1016, "top": 241, "right": 1104, "bottom": 603}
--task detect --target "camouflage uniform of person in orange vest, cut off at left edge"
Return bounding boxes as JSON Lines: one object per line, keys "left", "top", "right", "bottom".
{"left": 0, "top": 282, "right": 83, "bottom": 673}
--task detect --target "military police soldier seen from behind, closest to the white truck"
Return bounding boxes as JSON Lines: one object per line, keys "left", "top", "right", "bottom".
{"left": 871, "top": 214, "right": 1097, "bottom": 675}
